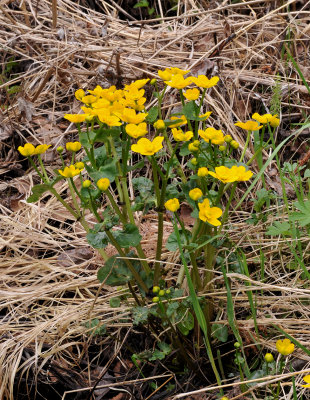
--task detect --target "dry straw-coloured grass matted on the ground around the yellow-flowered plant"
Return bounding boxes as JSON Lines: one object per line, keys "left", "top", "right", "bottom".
{"left": 0, "top": 0, "right": 310, "bottom": 400}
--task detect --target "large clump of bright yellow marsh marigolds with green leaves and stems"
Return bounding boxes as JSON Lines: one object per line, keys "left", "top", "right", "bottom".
{"left": 18, "top": 68, "right": 286, "bottom": 385}
